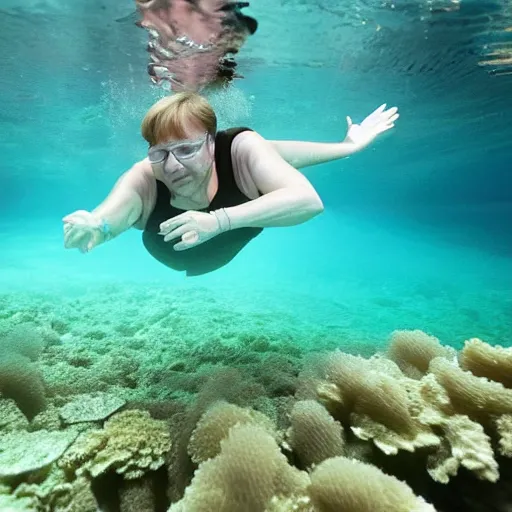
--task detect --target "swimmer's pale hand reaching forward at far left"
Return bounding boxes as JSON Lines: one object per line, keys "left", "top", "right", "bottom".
{"left": 62, "top": 210, "right": 104, "bottom": 253}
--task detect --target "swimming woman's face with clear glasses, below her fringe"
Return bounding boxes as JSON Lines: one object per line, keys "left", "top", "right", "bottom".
{"left": 148, "top": 123, "right": 214, "bottom": 196}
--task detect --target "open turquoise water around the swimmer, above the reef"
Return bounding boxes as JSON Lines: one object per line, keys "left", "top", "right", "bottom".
{"left": 0, "top": 0, "right": 512, "bottom": 344}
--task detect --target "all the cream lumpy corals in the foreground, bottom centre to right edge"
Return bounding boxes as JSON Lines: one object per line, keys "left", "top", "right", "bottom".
{"left": 169, "top": 331, "right": 511, "bottom": 512}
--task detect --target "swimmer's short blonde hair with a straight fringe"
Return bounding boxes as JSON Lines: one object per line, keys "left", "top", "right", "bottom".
{"left": 141, "top": 91, "right": 217, "bottom": 146}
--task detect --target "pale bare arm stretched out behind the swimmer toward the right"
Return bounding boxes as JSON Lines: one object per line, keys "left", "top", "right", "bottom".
{"left": 269, "top": 104, "right": 399, "bottom": 169}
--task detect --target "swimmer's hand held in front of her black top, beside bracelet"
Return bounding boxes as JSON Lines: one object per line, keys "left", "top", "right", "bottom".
{"left": 159, "top": 210, "right": 221, "bottom": 251}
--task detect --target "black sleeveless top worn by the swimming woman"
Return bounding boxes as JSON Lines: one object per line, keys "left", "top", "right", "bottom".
{"left": 142, "top": 128, "right": 263, "bottom": 276}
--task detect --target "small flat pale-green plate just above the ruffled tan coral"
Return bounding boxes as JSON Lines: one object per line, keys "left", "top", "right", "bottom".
{"left": 59, "top": 393, "right": 126, "bottom": 425}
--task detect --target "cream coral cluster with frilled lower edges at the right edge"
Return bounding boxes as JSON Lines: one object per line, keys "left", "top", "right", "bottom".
{"left": 300, "top": 331, "right": 512, "bottom": 483}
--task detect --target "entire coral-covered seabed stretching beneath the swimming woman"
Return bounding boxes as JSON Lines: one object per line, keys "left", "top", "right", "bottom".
{"left": 0, "top": 299, "right": 512, "bottom": 512}
